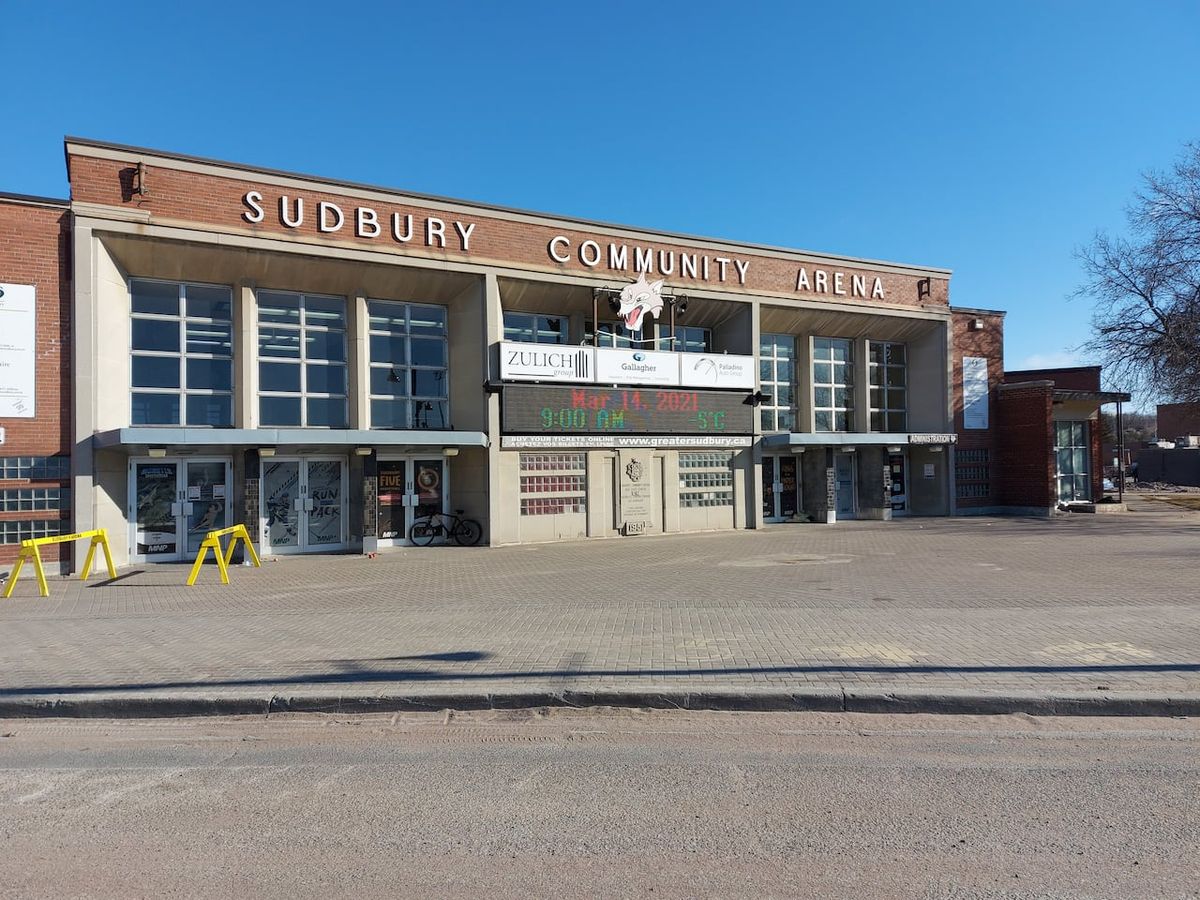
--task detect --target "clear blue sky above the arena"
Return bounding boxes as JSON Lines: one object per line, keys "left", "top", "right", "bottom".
{"left": 0, "top": 0, "right": 1200, "bottom": 381}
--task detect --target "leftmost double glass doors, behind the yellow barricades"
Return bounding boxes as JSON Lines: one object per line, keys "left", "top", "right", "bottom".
{"left": 130, "top": 458, "right": 230, "bottom": 563}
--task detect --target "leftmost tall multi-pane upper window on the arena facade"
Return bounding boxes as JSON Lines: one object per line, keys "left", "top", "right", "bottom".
{"left": 130, "top": 278, "right": 233, "bottom": 427}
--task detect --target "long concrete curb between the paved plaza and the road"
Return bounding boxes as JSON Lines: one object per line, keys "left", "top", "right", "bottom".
{"left": 0, "top": 686, "right": 1200, "bottom": 719}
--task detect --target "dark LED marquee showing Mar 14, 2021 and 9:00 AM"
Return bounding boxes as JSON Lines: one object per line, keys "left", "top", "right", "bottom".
{"left": 502, "top": 385, "right": 754, "bottom": 434}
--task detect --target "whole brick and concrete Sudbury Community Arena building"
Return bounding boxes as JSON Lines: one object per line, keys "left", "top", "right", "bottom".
{"left": 0, "top": 138, "right": 1127, "bottom": 578}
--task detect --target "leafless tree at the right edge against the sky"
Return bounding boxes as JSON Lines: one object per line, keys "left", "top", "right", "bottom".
{"left": 1075, "top": 144, "right": 1200, "bottom": 401}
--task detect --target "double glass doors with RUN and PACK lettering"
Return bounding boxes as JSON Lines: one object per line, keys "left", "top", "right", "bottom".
{"left": 260, "top": 456, "right": 347, "bottom": 553}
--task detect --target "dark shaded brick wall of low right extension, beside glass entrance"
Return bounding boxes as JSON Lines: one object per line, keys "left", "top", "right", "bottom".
{"left": 995, "top": 382, "right": 1057, "bottom": 509}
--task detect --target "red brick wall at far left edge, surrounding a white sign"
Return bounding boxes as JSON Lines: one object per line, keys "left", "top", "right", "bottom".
{"left": 0, "top": 196, "right": 71, "bottom": 566}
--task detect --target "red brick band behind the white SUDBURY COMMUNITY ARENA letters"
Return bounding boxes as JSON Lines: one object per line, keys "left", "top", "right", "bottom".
{"left": 68, "top": 151, "right": 949, "bottom": 307}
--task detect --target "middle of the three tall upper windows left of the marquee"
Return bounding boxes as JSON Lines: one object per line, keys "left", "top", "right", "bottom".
{"left": 258, "top": 290, "right": 347, "bottom": 428}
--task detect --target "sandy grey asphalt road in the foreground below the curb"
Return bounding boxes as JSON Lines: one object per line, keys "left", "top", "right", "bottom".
{"left": 0, "top": 710, "right": 1200, "bottom": 900}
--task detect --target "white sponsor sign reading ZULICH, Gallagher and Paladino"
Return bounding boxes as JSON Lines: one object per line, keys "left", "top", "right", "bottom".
{"left": 500, "top": 341, "right": 755, "bottom": 390}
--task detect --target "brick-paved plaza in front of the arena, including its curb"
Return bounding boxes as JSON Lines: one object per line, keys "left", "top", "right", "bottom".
{"left": 0, "top": 499, "right": 1200, "bottom": 716}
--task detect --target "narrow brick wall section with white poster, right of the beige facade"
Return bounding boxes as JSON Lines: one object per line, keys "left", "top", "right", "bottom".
{"left": 950, "top": 310, "right": 1004, "bottom": 509}
